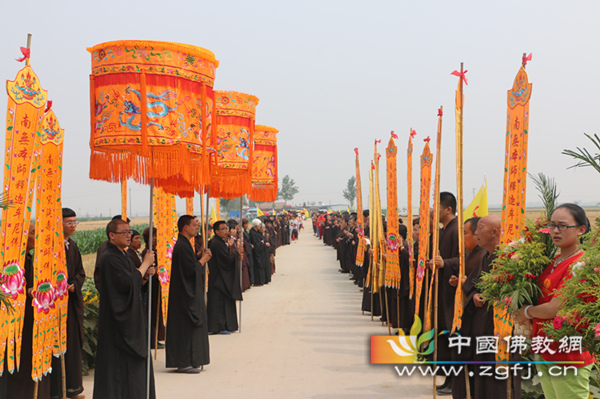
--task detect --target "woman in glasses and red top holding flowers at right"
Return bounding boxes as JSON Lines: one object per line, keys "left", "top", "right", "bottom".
{"left": 520, "top": 204, "right": 594, "bottom": 399}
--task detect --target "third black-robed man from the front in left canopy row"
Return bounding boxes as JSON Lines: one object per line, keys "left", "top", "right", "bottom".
{"left": 206, "top": 220, "right": 243, "bottom": 334}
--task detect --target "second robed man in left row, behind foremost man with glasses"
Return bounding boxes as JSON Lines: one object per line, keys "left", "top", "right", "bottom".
{"left": 165, "top": 215, "right": 216, "bottom": 373}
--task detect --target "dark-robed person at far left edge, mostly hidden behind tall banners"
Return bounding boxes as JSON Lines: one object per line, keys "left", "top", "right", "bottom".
{"left": 0, "top": 222, "right": 50, "bottom": 399}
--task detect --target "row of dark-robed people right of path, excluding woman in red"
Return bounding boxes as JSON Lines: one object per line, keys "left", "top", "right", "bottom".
{"left": 312, "top": 192, "right": 521, "bottom": 399}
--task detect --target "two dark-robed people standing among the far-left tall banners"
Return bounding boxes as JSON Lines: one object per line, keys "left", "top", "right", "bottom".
{"left": 0, "top": 208, "right": 85, "bottom": 399}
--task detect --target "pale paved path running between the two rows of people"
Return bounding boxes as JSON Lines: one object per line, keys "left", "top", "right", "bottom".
{"left": 84, "top": 224, "right": 432, "bottom": 399}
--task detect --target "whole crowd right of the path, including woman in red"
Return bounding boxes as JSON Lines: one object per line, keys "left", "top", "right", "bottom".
{"left": 312, "top": 197, "right": 594, "bottom": 399}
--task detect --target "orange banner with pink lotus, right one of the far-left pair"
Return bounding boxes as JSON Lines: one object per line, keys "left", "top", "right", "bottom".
{"left": 31, "top": 110, "right": 68, "bottom": 381}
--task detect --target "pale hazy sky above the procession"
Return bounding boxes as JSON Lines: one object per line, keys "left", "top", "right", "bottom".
{"left": 0, "top": 0, "right": 600, "bottom": 219}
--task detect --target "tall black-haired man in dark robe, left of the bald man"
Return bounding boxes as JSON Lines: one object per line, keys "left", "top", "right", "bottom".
{"left": 430, "top": 191, "right": 460, "bottom": 394}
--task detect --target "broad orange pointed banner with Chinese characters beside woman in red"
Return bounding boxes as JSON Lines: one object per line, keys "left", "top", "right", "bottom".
{"left": 494, "top": 60, "right": 532, "bottom": 361}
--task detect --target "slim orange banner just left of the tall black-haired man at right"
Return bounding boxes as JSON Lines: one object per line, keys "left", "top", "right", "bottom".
{"left": 415, "top": 141, "right": 433, "bottom": 316}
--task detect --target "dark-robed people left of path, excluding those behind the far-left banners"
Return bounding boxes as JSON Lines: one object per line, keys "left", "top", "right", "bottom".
{"left": 94, "top": 215, "right": 296, "bottom": 398}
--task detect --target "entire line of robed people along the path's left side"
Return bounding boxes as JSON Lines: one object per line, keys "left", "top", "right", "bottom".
{"left": 0, "top": 208, "right": 310, "bottom": 399}
